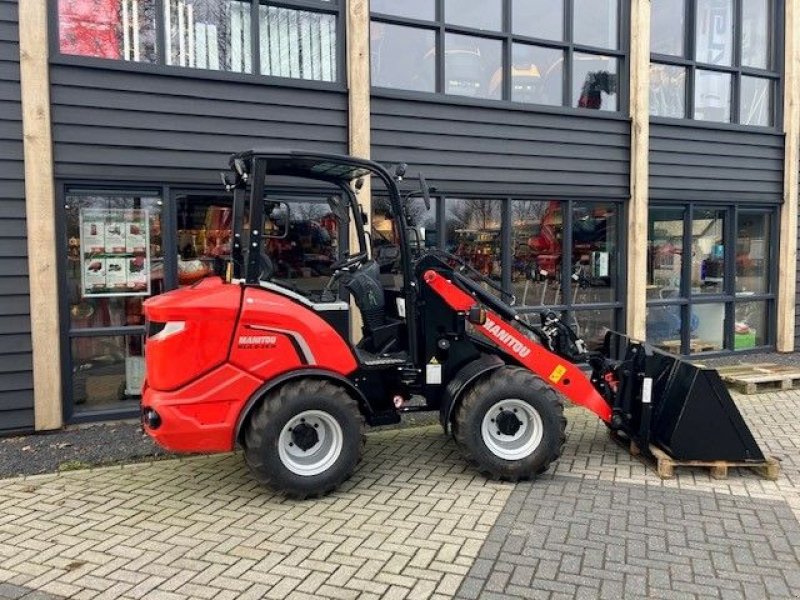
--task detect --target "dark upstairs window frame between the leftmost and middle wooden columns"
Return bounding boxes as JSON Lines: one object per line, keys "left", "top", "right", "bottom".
{"left": 48, "top": 0, "right": 347, "bottom": 91}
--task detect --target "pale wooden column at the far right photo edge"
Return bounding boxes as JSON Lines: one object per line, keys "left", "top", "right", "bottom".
{"left": 776, "top": 0, "right": 800, "bottom": 352}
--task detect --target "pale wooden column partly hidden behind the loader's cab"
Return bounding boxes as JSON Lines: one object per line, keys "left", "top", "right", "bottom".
{"left": 347, "top": 0, "right": 372, "bottom": 340}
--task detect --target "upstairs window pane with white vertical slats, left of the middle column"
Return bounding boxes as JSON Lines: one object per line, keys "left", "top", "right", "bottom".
{"left": 259, "top": 5, "right": 337, "bottom": 81}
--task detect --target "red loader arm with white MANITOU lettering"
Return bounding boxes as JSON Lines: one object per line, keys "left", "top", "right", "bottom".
{"left": 423, "top": 269, "right": 612, "bottom": 423}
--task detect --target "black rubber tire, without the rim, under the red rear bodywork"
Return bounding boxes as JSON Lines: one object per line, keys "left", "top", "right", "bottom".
{"left": 243, "top": 379, "right": 366, "bottom": 499}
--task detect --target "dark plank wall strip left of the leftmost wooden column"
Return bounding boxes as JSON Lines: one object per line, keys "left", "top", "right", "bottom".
{"left": 0, "top": 0, "right": 32, "bottom": 432}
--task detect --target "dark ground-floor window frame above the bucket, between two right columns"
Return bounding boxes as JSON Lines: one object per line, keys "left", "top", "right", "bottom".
{"left": 646, "top": 201, "right": 780, "bottom": 357}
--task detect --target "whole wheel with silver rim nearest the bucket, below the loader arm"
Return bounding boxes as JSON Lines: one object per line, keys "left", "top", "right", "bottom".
{"left": 453, "top": 366, "right": 567, "bottom": 481}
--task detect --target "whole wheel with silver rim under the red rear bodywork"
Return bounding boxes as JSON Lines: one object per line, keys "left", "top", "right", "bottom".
{"left": 244, "top": 379, "right": 365, "bottom": 498}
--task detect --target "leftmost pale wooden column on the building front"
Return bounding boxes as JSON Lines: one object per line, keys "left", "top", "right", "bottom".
{"left": 19, "top": 0, "right": 63, "bottom": 430}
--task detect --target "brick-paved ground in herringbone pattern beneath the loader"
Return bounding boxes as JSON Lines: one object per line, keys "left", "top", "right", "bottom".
{"left": 0, "top": 392, "right": 800, "bottom": 600}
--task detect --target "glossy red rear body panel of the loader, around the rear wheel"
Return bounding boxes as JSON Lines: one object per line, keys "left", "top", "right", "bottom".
{"left": 142, "top": 278, "right": 358, "bottom": 452}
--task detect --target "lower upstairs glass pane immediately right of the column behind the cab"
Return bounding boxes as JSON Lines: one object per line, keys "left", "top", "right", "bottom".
{"left": 370, "top": 21, "right": 436, "bottom": 92}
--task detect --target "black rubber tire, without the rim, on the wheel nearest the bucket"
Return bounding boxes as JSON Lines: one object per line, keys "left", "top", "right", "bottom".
{"left": 453, "top": 366, "right": 567, "bottom": 481}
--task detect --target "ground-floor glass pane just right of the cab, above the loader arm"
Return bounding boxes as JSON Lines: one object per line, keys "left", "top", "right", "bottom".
{"left": 444, "top": 198, "right": 502, "bottom": 282}
